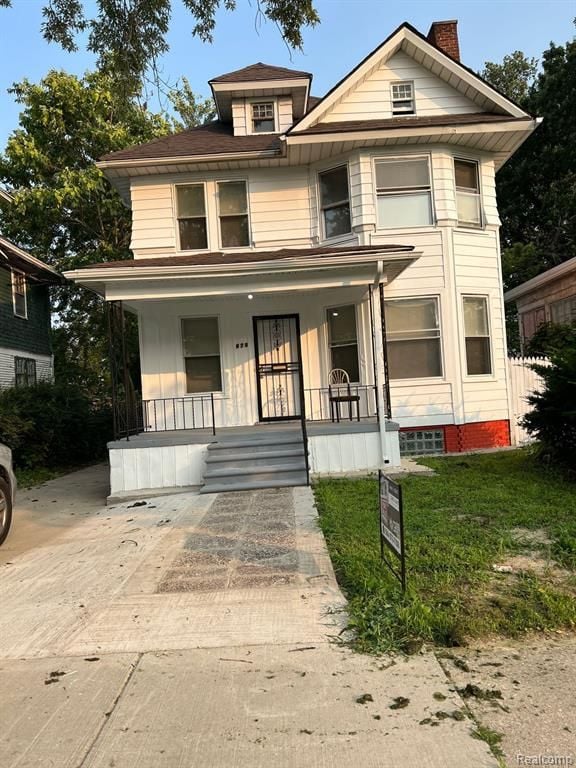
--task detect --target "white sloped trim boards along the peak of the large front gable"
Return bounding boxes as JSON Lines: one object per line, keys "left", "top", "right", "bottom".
{"left": 287, "top": 22, "right": 527, "bottom": 134}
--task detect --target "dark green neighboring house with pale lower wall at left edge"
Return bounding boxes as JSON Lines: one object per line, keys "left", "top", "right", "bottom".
{"left": 0, "top": 190, "right": 61, "bottom": 389}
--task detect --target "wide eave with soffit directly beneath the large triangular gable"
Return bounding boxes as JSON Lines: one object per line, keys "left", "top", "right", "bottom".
{"left": 285, "top": 116, "right": 542, "bottom": 169}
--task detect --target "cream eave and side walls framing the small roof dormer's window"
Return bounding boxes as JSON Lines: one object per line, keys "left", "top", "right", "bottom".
{"left": 209, "top": 77, "right": 310, "bottom": 122}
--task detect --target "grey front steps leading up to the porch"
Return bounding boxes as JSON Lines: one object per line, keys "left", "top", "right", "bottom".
{"left": 200, "top": 429, "right": 306, "bottom": 493}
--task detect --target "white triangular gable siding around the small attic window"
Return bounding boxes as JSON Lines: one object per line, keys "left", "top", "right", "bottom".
{"left": 322, "top": 51, "right": 482, "bottom": 123}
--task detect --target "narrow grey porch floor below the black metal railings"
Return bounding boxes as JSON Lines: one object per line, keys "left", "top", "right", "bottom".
{"left": 108, "top": 417, "right": 388, "bottom": 449}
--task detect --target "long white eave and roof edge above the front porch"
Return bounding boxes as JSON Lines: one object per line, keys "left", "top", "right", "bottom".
{"left": 65, "top": 248, "right": 422, "bottom": 302}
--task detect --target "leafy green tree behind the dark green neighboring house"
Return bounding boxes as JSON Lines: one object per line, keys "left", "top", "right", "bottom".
{"left": 0, "top": 71, "right": 169, "bottom": 393}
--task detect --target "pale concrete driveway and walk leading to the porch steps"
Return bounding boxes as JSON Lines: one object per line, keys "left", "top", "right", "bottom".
{"left": 0, "top": 467, "right": 497, "bottom": 768}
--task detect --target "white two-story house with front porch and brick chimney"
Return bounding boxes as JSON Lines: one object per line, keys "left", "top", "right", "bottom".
{"left": 67, "top": 21, "right": 538, "bottom": 495}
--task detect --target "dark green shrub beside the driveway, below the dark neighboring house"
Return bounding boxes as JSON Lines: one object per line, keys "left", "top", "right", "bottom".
{"left": 0, "top": 382, "right": 112, "bottom": 469}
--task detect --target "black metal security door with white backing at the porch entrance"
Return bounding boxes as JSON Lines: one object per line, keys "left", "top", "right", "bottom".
{"left": 254, "top": 315, "right": 302, "bottom": 421}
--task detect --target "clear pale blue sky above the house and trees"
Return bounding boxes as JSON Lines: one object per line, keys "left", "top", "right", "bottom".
{"left": 0, "top": 0, "right": 576, "bottom": 148}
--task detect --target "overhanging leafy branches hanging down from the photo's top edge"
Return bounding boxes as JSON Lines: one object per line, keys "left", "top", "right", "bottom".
{"left": 0, "top": 0, "right": 320, "bottom": 93}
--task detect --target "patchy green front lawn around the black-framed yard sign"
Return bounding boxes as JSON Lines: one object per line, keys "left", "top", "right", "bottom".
{"left": 314, "top": 449, "right": 576, "bottom": 653}
